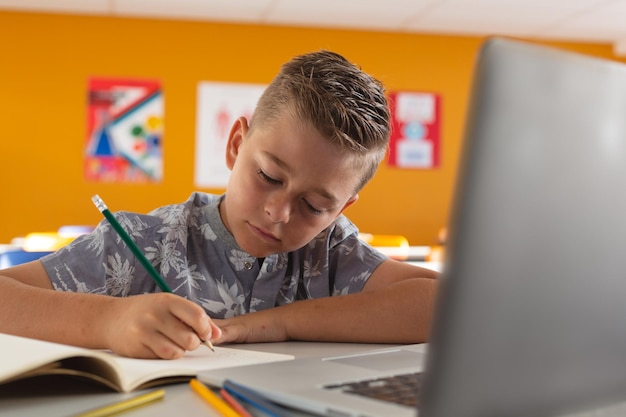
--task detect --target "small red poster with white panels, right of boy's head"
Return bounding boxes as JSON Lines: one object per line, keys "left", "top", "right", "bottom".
{"left": 388, "top": 92, "right": 441, "bottom": 169}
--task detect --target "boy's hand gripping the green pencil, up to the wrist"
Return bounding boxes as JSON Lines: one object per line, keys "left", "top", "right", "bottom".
{"left": 100, "top": 293, "right": 222, "bottom": 359}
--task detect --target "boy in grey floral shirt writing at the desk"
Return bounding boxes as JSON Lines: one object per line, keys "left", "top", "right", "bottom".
{"left": 0, "top": 51, "right": 436, "bottom": 359}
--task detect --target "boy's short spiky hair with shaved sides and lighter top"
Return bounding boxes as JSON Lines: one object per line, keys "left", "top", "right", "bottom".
{"left": 250, "top": 50, "right": 391, "bottom": 193}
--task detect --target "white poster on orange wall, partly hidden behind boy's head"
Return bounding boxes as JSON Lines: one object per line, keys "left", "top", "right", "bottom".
{"left": 194, "top": 81, "right": 267, "bottom": 188}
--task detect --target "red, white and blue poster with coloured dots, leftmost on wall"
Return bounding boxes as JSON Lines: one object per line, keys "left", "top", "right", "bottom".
{"left": 84, "top": 78, "right": 163, "bottom": 183}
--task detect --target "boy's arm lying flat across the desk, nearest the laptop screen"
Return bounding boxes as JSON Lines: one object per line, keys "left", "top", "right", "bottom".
{"left": 215, "top": 260, "right": 437, "bottom": 343}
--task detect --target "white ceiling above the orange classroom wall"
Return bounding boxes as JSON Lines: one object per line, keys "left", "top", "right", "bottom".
{"left": 0, "top": 0, "right": 626, "bottom": 55}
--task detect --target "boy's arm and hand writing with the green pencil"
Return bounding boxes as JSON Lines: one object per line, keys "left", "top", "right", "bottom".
{"left": 0, "top": 261, "right": 219, "bottom": 359}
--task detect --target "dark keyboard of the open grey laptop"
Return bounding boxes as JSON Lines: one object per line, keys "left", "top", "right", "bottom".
{"left": 324, "top": 372, "right": 422, "bottom": 407}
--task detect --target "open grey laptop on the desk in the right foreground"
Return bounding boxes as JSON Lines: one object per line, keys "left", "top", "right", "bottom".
{"left": 199, "top": 38, "right": 626, "bottom": 417}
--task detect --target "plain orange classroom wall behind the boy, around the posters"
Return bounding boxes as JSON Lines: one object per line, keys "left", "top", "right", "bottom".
{"left": 0, "top": 12, "right": 614, "bottom": 245}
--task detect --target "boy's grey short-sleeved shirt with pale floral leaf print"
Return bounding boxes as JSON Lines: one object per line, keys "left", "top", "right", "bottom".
{"left": 41, "top": 193, "right": 387, "bottom": 318}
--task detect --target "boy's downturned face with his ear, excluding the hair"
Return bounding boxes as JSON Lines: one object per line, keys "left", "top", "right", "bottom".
{"left": 220, "top": 115, "right": 360, "bottom": 257}
